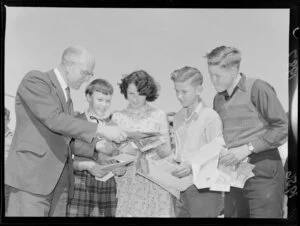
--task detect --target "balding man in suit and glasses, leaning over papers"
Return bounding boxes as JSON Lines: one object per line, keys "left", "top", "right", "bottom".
{"left": 5, "top": 46, "right": 126, "bottom": 216}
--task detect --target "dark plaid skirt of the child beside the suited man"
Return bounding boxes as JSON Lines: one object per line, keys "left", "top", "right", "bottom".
{"left": 67, "top": 171, "right": 117, "bottom": 217}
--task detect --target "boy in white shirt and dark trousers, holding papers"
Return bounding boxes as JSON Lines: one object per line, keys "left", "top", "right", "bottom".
{"left": 171, "top": 66, "right": 223, "bottom": 217}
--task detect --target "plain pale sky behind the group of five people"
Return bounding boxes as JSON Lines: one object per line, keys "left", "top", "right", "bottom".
{"left": 5, "top": 7, "right": 289, "bottom": 131}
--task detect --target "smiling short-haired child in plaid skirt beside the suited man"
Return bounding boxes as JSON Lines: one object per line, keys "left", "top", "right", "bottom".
{"left": 67, "top": 79, "right": 125, "bottom": 217}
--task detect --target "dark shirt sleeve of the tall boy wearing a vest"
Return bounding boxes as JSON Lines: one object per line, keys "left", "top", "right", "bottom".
{"left": 251, "top": 79, "right": 288, "bottom": 152}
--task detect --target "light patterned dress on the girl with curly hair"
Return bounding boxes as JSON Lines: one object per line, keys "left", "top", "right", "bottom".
{"left": 112, "top": 105, "right": 175, "bottom": 217}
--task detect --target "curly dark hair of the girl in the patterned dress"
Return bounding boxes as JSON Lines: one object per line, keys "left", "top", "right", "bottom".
{"left": 118, "top": 70, "right": 159, "bottom": 102}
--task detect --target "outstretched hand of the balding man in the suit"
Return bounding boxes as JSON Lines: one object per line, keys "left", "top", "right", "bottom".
{"left": 96, "top": 124, "right": 127, "bottom": 143}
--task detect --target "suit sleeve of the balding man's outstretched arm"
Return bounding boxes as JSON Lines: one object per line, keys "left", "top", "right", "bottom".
{"left": 17, "top": 71, "right": 98, "bottom": 143}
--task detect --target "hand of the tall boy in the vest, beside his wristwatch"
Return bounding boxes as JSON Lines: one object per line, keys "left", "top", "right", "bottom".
{"left": 220, "top": 144, "right": 251, "bottom": 167}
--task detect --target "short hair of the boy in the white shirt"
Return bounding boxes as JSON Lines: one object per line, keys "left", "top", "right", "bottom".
{"left": 171, "top": 66, "right": 203, "bottom": 85}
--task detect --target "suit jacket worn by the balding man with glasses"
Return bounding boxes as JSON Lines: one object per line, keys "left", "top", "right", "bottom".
{"left": 5, "top": 70, "right": 97, "bottom": 195}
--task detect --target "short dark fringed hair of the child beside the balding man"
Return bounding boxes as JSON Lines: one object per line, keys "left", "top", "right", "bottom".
{"left": 85, "top": 78, "right": 114, "bottom": 96}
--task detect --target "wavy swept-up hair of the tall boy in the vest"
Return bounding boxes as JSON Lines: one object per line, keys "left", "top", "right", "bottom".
{"left": 205, "top": 46, "right": 242, "bottom": 69}
